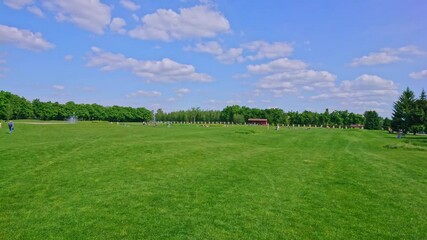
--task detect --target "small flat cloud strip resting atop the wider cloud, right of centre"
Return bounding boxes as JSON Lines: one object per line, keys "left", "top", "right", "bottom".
{"left": 247, "top": 58, "right": 307, "bottom": 74}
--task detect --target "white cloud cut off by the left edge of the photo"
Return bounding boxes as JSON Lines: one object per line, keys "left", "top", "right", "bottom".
{"left": 0, "top": 24, "right": 55, "bottom": 51}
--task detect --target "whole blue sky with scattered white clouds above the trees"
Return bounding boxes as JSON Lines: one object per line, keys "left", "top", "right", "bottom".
{"left": 0, "top": 0, "right": 427, "bottom": 116}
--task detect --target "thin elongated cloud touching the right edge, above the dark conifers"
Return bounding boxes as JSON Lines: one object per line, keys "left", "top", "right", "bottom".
{"left": 350, "top": 45, "right": 425, "bottom": 67}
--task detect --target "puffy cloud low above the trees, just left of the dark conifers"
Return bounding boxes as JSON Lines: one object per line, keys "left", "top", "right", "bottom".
{"left": 311, "top": 74, "right": 399, "bottom": 110}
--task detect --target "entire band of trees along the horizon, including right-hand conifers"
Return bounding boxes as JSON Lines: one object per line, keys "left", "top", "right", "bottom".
{"left": 0, "top": 88, "right": 427, "bottom": 132}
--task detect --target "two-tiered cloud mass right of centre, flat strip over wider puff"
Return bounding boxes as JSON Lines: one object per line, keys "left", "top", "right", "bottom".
{"left": 251, "top": 58, "right": 336, "bottom": 97}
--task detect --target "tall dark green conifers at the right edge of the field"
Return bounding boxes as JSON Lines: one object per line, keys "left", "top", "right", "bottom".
{"left": 391, "top": 88, "right": 427, "bottom": 134}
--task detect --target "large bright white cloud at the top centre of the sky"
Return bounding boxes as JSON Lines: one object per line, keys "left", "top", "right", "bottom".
{"left": 129, "top": 6, "right": 230, "bottom": 41}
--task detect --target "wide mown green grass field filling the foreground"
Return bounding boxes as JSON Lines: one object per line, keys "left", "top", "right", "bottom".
{"left": 0, "top": 122, "right": 427, "bottom": 239}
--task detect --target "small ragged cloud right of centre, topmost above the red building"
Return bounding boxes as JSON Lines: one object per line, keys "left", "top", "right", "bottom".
{"left": 242, "top": 41, "right": 293, "bottom": 60}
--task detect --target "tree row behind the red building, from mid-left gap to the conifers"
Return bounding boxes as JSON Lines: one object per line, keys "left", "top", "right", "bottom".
{"left": 156, "top": 105, "right": 390, "bottom": 129}
